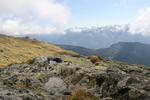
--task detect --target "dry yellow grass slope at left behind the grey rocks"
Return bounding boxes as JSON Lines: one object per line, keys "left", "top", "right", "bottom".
{"left": 0, "top": 34, "right": 78, "bottom": 67}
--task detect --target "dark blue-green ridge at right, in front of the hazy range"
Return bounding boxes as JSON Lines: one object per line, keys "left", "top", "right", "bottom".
{"left": 58, "top": 42, "right": 150, "bottom": 65}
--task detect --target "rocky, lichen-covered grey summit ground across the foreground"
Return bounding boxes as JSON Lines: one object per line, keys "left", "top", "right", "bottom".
{"left": 0, "top": 56, "right": 150, "bottom": 100}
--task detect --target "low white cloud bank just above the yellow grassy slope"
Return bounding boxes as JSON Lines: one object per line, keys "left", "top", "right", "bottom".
{"left": 0, "top": 19, "right": 58, "bottom": 35}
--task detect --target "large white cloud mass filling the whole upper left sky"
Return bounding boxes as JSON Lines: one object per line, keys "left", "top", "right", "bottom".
{"left": 0, "top": 0, "right": 68, "bottom": 35}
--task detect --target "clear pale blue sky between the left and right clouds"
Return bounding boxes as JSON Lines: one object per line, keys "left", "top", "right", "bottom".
{"left": 66, "top": 0, "right": 150, "bottom": 26}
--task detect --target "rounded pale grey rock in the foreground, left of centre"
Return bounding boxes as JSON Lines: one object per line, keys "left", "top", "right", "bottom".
{"left": 45, "top": 78, "right": 67, "bottom": 94}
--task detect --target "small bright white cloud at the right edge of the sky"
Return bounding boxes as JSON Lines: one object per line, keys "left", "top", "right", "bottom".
{"left": 130, "top": 8, "right": 150, "bottom": 36}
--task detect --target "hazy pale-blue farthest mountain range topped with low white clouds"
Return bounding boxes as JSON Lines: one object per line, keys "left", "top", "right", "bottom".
{"left": 31, "top": 25, "right": 150, "bottom": 49}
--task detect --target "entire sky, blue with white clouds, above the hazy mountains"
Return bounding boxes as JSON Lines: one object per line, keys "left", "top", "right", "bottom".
{"left": 0, "top": 0, "right": 150, "bottom": 36}
